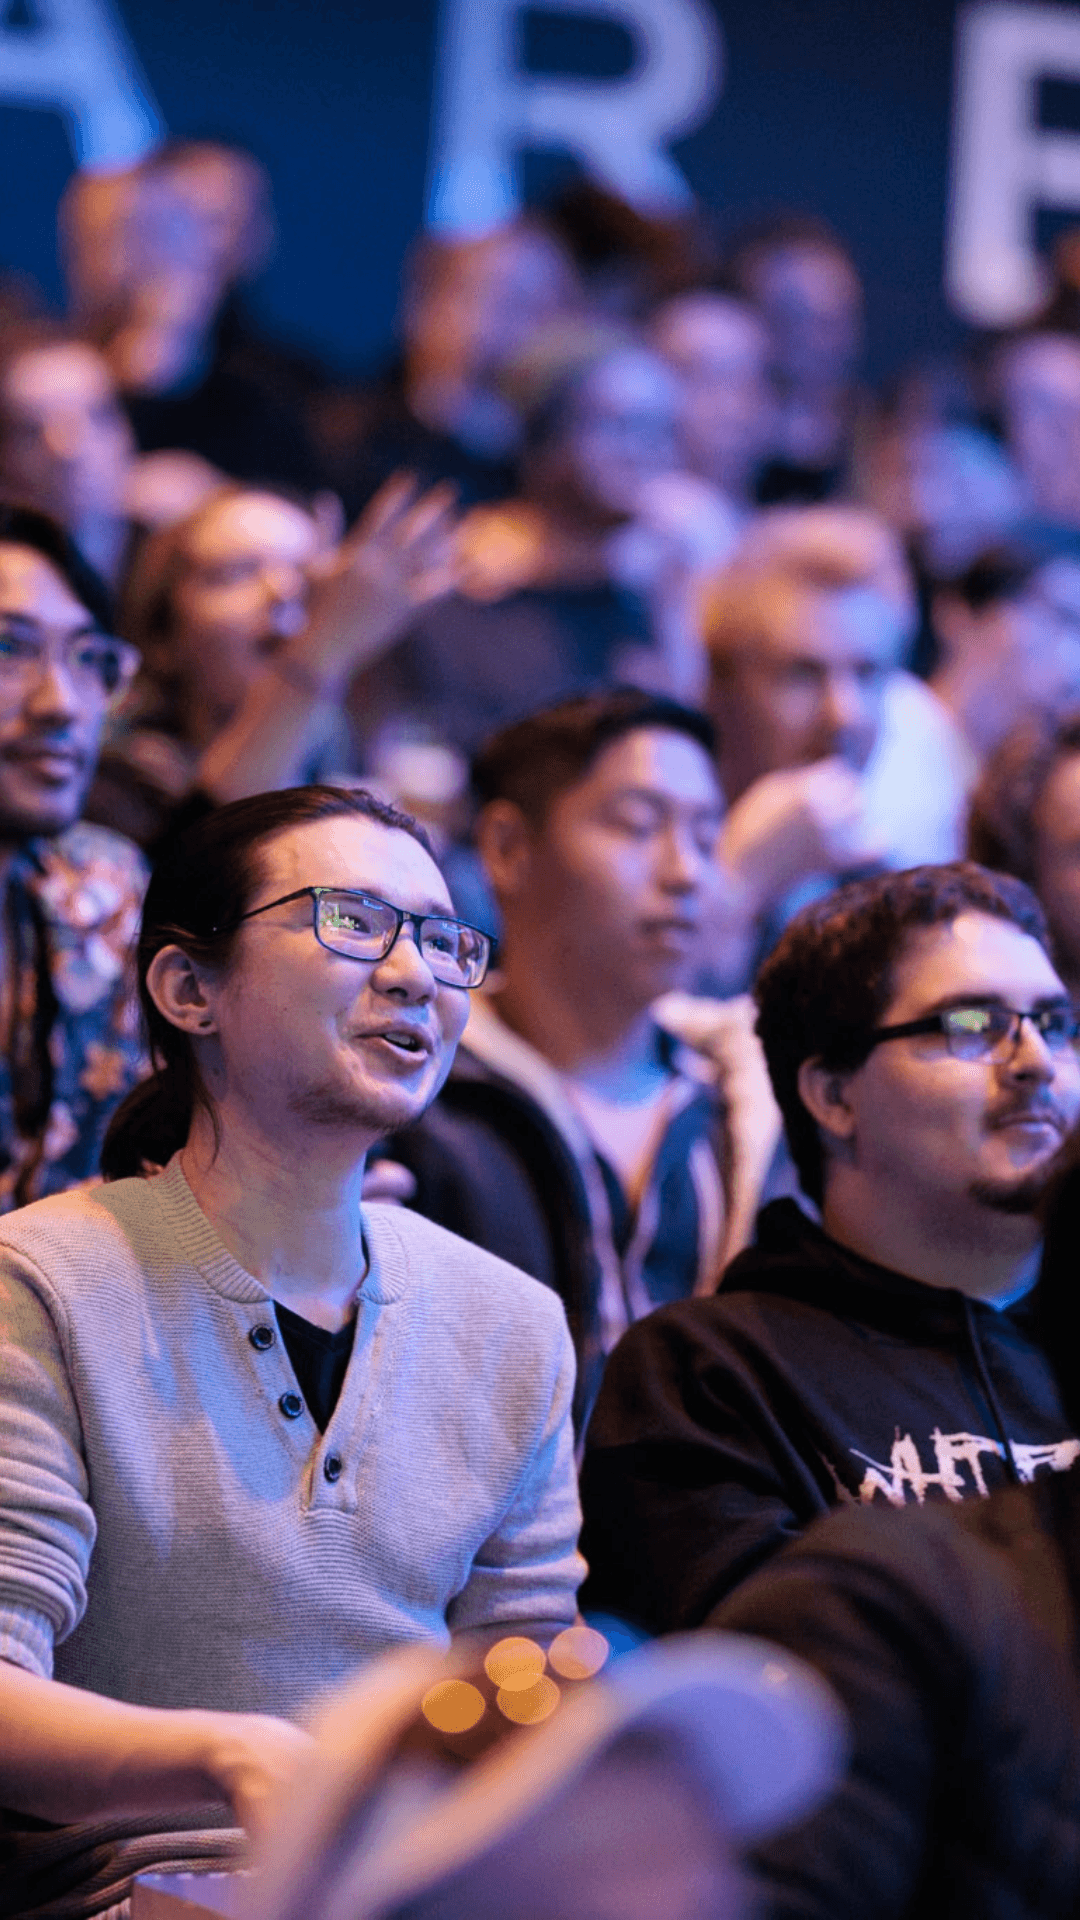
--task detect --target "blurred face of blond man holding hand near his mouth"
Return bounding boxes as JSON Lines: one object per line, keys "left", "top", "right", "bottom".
{"left": 709, "top": 588, "right": 901, "bottom": 799}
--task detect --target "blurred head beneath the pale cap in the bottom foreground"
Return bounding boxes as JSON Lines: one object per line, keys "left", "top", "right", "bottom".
{"left": 419, "top": 1753, "right": 746, "bottom": 1920}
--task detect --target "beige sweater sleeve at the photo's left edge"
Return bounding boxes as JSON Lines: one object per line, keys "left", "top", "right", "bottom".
{"left": 0, "top": 1248, "right": 96, "bottom": 1678}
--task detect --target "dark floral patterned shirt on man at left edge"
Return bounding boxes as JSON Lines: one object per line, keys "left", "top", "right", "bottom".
{"left": 0, "top": 822, "right": 146, "bottom": 1212}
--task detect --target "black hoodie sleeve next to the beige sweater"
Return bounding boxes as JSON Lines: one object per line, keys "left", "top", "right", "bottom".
{"left": 582, "top": 1302, "right": 836, "bottom": 1634}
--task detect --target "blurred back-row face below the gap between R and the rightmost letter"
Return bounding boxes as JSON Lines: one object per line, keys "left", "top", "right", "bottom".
{"left": 753, "top": 244, "right": 863, "bottom": 386}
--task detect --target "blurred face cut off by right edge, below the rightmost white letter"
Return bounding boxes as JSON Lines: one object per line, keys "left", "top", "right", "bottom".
{"left": 990, "top": 330, "right": 1080, "bottom": 530}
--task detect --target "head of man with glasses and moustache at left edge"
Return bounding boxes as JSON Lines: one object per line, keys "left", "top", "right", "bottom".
{"left": 0, "top": 507, "right": 138, "bottom": 849}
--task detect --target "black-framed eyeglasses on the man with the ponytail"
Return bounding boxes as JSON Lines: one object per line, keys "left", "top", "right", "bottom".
{"left": 222, "top": 887, "right": 492, "bottom": 987}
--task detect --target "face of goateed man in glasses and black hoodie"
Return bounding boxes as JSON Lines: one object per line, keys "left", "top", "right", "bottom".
{"left": 834, "top": 912, "right": 1080, "bottom": 1217}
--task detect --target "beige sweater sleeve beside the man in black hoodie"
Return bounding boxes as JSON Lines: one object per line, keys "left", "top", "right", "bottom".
{"left": 446, "top": 1309, "right": 586, "bottom": 1634}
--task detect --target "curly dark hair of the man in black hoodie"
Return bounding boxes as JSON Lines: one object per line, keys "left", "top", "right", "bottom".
{"left": 753, "top": 860, "right": 1049, "bottom": 1202}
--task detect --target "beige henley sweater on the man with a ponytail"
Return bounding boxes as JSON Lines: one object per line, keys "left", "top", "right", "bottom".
{"left": 0, "top": 1160, "right": 584, "bottom": 1715}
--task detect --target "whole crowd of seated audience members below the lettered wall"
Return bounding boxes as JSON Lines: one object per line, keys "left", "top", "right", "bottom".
{"left": 8, "top": 140, "right": 1080, "bottom": 1920}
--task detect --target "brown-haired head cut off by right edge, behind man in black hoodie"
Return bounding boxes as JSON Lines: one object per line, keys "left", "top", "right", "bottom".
{"left": 969, "top": 712, "right": 1080, "bottom": 993}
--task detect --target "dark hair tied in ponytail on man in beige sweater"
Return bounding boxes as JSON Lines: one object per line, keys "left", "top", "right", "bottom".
{"left": 102, "top": 785, "right": 434, "bottom": 1181}
